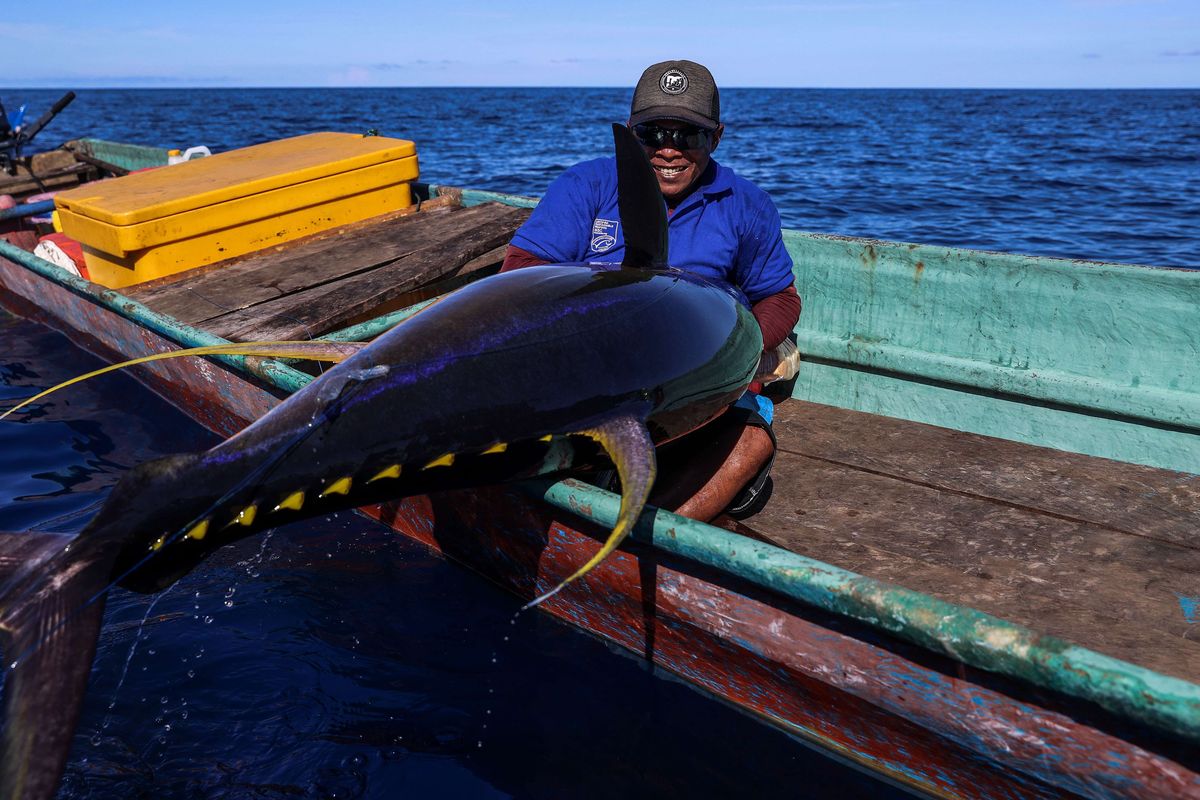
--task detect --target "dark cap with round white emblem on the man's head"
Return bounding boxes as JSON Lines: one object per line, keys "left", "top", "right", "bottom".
{"left": 629, "top": 61, "right": 721, "bottom": 130}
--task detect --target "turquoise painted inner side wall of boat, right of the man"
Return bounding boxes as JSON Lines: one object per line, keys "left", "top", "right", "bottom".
{"left": 784, "top": 230, "right": 1200, "bottom": 473}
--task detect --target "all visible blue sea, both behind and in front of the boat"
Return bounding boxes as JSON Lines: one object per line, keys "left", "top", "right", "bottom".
{"left": 0, "top": 89, "right": 1200, "bottom": 800}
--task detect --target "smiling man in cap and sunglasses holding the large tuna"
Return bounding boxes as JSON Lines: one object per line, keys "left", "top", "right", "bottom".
{"left": 502, "top": 61, "right": 800, "bottom": 522}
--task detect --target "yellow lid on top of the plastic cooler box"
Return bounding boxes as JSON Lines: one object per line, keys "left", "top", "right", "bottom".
{"left": 55, "top": 132, "right": 418, "bottom": 253}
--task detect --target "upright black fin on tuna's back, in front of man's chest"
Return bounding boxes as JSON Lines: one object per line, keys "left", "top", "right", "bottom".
{"left": 612, "top": 122, "right": 667, "bottom": 270}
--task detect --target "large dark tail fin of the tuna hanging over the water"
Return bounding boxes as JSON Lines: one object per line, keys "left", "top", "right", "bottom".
{"left": 0, "top": 533, "right": 110, "bottom": 800}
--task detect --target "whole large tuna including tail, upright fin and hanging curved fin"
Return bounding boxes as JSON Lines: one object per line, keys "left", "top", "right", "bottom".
{"left": 0, "top": 126, "right": 762, "bottom": 800}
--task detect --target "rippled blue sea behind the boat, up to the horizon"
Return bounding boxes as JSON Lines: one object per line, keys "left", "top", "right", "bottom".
{"left": 11, "top": 89, "right": 1200, "bottom": 267}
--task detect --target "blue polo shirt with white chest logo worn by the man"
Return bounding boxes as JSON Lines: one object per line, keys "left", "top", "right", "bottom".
{"left": 512, "top": 158, "right": 792, "bottom": 303}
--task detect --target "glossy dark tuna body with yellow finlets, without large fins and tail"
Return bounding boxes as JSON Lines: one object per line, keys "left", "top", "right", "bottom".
{"left": 103, "top": 266, "right": 762, "bottom": 590}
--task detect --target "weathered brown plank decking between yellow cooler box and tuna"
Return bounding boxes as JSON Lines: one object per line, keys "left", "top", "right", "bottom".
{"left": 126, "top": 203, "right": 529, "bottom": 342}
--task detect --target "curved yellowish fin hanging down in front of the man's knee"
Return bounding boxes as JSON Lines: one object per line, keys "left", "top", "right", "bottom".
{"left": 524, "top": 416, "right": 658, "bottom": 608}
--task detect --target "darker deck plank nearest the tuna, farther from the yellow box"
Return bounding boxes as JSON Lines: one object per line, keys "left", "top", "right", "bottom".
{"left": 204, "top": 205, "right": 529, "bottom": 341}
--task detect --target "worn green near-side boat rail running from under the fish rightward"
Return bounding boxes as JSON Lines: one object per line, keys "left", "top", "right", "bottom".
{"left": 521, "top": 480, "right": 1200, "bottom": 742}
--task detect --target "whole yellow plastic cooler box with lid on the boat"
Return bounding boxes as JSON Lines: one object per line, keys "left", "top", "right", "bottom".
{"left": 54, "top": 133, "right": 418, "bottom": 289}
